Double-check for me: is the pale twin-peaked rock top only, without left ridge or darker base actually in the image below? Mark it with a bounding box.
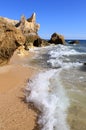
[16,13,40,36]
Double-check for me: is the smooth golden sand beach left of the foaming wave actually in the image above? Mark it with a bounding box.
[0,51,37,130]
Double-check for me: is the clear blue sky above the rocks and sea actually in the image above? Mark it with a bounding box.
[0,0,86,39]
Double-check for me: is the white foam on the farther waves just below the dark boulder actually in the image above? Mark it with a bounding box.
[47,45,82,68]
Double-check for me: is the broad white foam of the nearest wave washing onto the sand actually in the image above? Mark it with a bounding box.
[26,69,69,130]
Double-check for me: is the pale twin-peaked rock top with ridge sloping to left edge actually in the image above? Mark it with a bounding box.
[0,13,40,36]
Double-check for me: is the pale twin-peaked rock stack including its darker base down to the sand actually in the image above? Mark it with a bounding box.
[15,13,40,50]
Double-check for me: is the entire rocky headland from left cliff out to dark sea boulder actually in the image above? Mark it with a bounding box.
[0,13,74,65]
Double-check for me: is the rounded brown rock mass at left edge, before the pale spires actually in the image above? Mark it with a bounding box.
[0,18,25,64]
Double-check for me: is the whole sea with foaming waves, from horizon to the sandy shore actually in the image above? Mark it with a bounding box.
[26,40,86,130]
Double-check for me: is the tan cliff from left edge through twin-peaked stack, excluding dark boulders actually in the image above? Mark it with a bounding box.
[0,13,40,64]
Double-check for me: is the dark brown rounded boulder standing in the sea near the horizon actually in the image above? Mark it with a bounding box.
[49,33,65,44]
